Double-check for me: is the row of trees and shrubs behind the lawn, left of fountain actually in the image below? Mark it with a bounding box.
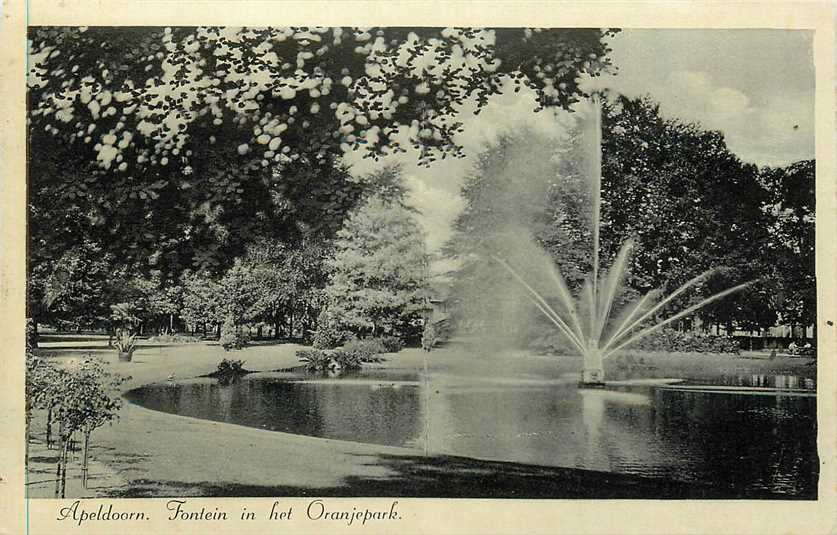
[28,167,428,346]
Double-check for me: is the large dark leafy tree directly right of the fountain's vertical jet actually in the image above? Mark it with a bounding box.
[602,97,775,329]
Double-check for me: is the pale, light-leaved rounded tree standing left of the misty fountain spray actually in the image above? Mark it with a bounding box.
[325,198,428,336]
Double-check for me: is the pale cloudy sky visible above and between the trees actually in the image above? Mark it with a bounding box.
[342,29,814,272]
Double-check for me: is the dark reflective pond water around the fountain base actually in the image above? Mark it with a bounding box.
[127,370,818,498]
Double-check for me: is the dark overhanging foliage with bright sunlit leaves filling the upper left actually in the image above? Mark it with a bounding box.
[28,27,614,276]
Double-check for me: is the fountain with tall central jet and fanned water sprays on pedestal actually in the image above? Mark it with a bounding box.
[494,94,753,387]
